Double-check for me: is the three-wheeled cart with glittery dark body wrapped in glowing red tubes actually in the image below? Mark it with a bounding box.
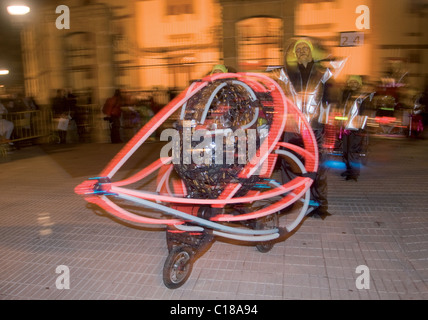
[75,73,318,288]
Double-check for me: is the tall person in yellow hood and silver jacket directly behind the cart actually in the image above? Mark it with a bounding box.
[280,38,333,219]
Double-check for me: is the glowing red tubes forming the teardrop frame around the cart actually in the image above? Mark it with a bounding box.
[75,73,318,225]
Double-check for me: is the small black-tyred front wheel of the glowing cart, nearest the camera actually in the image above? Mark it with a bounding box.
[163,246,193,289]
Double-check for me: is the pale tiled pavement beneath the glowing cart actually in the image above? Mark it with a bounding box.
[0,132,428,300]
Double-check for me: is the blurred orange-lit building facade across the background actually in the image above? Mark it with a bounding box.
[18,0,428,104]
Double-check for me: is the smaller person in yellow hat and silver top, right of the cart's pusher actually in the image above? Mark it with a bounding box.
[339,75,373,181]
